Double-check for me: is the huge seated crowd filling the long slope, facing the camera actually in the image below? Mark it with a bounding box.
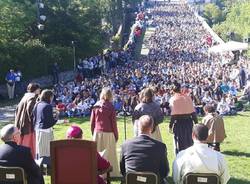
[50,4,250,120]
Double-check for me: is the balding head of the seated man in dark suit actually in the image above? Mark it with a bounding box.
[139,115,154,134]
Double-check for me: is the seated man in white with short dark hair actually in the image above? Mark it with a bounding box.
[173,124,230,184]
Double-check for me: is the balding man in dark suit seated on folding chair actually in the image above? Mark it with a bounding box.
[120,115,169,184]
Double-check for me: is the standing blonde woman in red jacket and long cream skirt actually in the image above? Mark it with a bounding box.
[90,87,120,176]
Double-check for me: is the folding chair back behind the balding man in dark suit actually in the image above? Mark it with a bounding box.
[126,172,158,184]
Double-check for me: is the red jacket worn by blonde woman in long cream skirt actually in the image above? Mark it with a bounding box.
[90,100,118,140]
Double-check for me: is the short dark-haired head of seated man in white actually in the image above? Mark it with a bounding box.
[193,123,208,142]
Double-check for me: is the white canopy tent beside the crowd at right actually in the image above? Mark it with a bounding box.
[209,41,248,53]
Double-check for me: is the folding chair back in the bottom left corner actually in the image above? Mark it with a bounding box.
[0,166,27,184]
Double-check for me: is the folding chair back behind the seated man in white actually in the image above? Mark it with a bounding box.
[183,173,220,184]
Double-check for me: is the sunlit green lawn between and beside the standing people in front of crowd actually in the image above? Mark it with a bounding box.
[42,112,250,184]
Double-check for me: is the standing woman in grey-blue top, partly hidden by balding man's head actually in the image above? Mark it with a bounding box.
[132,88,164,141]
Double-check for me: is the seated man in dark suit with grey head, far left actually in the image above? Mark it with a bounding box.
[0,124,44,184]
